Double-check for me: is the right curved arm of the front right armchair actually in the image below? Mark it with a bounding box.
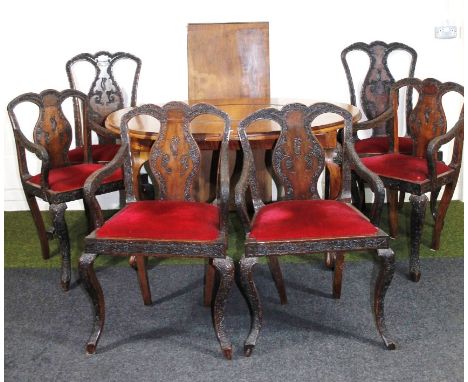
[345,141,385,226]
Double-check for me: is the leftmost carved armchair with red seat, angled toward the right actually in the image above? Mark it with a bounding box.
[7,89,123,291]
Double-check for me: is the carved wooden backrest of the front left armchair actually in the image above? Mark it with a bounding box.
[120,102,231,201]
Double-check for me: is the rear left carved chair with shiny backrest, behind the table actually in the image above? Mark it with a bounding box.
[65,51,141,163]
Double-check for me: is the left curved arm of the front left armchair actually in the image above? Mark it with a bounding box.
[83,144,128,229]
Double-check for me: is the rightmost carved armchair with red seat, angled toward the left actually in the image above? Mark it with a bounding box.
[355,78,464,281]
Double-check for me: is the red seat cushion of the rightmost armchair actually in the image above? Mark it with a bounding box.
[362,154,452,182]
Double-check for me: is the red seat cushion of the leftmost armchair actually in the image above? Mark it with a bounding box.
[29,163,123,192]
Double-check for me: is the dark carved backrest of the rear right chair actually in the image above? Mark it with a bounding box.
[341,41,417,136]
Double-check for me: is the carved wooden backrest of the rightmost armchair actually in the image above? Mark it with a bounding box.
[391,78,464,161]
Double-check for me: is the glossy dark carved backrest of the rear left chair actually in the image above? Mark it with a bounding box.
[65,51,141,146]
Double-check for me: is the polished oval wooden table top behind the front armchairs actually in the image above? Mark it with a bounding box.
[105,98,361,141]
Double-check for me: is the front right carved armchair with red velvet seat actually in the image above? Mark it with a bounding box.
[235,103,395,356]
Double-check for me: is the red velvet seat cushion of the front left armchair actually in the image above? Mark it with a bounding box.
[96,200,219,241]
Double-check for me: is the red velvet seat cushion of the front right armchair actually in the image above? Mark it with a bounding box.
[250,200,377,241]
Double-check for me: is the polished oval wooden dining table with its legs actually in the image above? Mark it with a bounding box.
[105,98,361,200]
